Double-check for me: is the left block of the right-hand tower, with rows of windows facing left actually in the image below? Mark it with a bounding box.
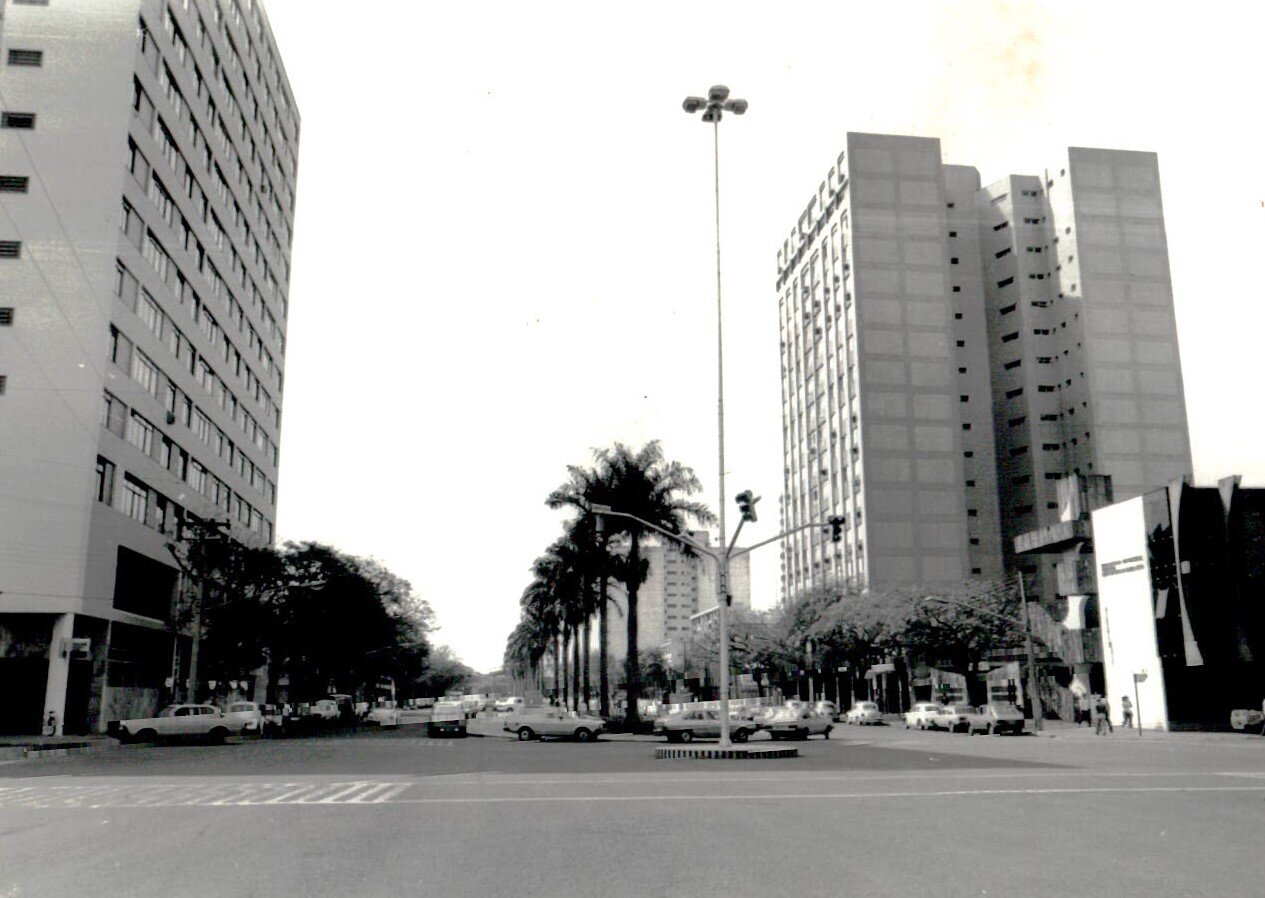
[777,134,1001,598]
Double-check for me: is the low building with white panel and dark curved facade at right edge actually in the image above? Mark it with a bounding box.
[1093,477,1265,730]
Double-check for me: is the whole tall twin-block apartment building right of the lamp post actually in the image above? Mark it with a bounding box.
[777,134,1190,609]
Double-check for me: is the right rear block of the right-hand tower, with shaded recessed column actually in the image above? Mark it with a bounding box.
[977,148,1192,569]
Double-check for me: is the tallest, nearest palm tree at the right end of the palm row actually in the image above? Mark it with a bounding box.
[593,440,715,730]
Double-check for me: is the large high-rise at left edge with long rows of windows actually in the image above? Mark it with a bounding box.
[0,0,299,732]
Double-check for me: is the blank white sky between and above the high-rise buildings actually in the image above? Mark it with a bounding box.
[266,0,1265,670]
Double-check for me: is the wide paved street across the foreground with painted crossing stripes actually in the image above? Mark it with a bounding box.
[0,727,1265,897]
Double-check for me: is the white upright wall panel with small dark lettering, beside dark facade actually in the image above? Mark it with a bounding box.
[1093,496,1169,730]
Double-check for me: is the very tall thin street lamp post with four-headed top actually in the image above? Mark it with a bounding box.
[681,85,746,747]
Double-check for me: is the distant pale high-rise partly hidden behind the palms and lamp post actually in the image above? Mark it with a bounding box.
[595,530,751,658]
